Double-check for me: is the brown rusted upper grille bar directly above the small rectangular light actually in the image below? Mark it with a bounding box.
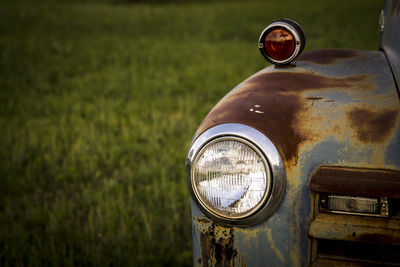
[310,166,400,198]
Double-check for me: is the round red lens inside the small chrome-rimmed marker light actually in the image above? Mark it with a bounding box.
[265,29,295,60]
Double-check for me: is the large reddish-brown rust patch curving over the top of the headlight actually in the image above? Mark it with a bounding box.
[197,71,368,164]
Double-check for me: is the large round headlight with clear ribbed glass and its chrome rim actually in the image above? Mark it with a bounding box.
[186,123,286,225]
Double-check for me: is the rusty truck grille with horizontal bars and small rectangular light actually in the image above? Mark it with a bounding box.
[308,166,400,266]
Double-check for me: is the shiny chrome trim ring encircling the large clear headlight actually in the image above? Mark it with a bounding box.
[186,123,286,226]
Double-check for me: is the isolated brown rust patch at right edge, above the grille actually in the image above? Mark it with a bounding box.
[347,108,398,143]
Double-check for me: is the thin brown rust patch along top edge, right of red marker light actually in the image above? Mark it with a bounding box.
[298,49,358,65]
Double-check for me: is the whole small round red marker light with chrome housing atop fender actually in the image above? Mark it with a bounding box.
[258,19,305,65]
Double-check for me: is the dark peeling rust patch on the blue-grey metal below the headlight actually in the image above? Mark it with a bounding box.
[198,223,237,267]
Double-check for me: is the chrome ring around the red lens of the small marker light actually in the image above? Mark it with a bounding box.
[258,19,306,65]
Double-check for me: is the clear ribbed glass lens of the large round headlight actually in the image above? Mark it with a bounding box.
[192,137,271,218]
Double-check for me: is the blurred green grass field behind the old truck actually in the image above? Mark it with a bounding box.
[0,0,382,266]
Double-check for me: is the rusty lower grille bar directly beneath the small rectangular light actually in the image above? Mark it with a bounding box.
[309,213,400,245]
